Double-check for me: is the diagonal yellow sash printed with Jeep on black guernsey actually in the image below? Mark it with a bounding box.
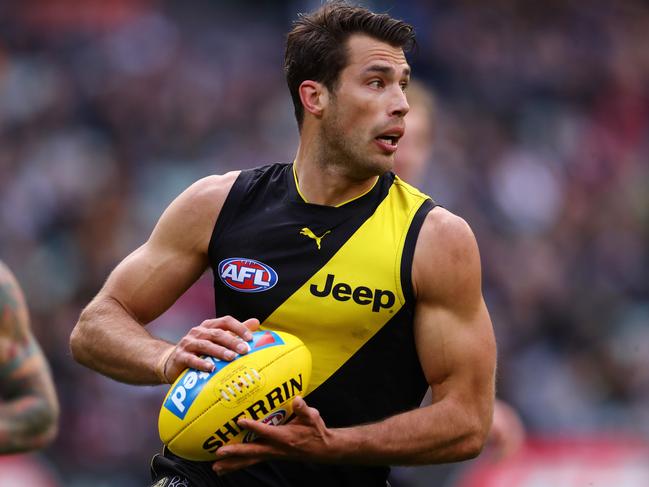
[262,178,428,392]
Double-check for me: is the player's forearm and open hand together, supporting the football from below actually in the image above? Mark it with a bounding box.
[212,395,493,474]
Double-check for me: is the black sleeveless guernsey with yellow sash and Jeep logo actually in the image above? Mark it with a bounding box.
[202,164,434,487]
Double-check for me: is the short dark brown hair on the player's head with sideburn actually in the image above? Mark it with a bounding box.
[284,0,415,128]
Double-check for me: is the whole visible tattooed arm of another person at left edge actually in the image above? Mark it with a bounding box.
[0,262,59,454]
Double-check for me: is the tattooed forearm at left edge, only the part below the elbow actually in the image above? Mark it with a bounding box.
[0,396,58,454]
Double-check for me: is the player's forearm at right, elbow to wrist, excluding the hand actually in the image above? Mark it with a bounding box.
[330,400,490,465]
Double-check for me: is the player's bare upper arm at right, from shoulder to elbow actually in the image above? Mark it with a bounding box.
[413,210,496,410]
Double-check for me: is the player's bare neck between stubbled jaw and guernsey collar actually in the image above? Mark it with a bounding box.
[295,142,378,206]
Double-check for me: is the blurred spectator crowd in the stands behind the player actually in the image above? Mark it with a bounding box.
[0,0,649,487]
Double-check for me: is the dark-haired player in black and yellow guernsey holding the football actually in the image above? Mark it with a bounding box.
[71,2,495,487]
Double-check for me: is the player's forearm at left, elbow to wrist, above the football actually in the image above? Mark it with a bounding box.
[70,297,172,384]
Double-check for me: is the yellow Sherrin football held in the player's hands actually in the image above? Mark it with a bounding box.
[158,330,311,460]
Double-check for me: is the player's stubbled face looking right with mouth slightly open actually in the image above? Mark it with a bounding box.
[322,35,410,178]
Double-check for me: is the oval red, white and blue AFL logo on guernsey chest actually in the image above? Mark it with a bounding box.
[219,257,277,293]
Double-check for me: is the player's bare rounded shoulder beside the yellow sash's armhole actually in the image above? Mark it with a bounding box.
[413,206,481,301]
